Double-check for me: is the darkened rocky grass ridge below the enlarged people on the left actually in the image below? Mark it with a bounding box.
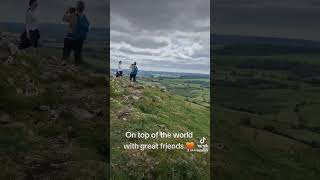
[0,33,108,179]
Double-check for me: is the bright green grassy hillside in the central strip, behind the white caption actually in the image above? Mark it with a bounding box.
[111,80,210,179]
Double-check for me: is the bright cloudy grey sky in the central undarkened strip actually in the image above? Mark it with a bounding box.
[110,0,210,74]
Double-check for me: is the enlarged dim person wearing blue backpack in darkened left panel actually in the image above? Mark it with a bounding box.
[62,1,90,66]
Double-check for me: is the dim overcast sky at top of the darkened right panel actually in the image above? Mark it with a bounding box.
[211,0,320,40]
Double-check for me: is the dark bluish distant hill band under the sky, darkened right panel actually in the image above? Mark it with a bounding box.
[211,34,320,56]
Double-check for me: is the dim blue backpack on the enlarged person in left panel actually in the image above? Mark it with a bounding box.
[73,16,90,40]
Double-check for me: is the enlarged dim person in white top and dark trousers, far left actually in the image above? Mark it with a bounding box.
[19,0,40,49]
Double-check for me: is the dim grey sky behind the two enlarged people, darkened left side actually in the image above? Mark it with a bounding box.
[0,0,109,27]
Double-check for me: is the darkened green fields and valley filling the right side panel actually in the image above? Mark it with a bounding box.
[213,45,320,180]
